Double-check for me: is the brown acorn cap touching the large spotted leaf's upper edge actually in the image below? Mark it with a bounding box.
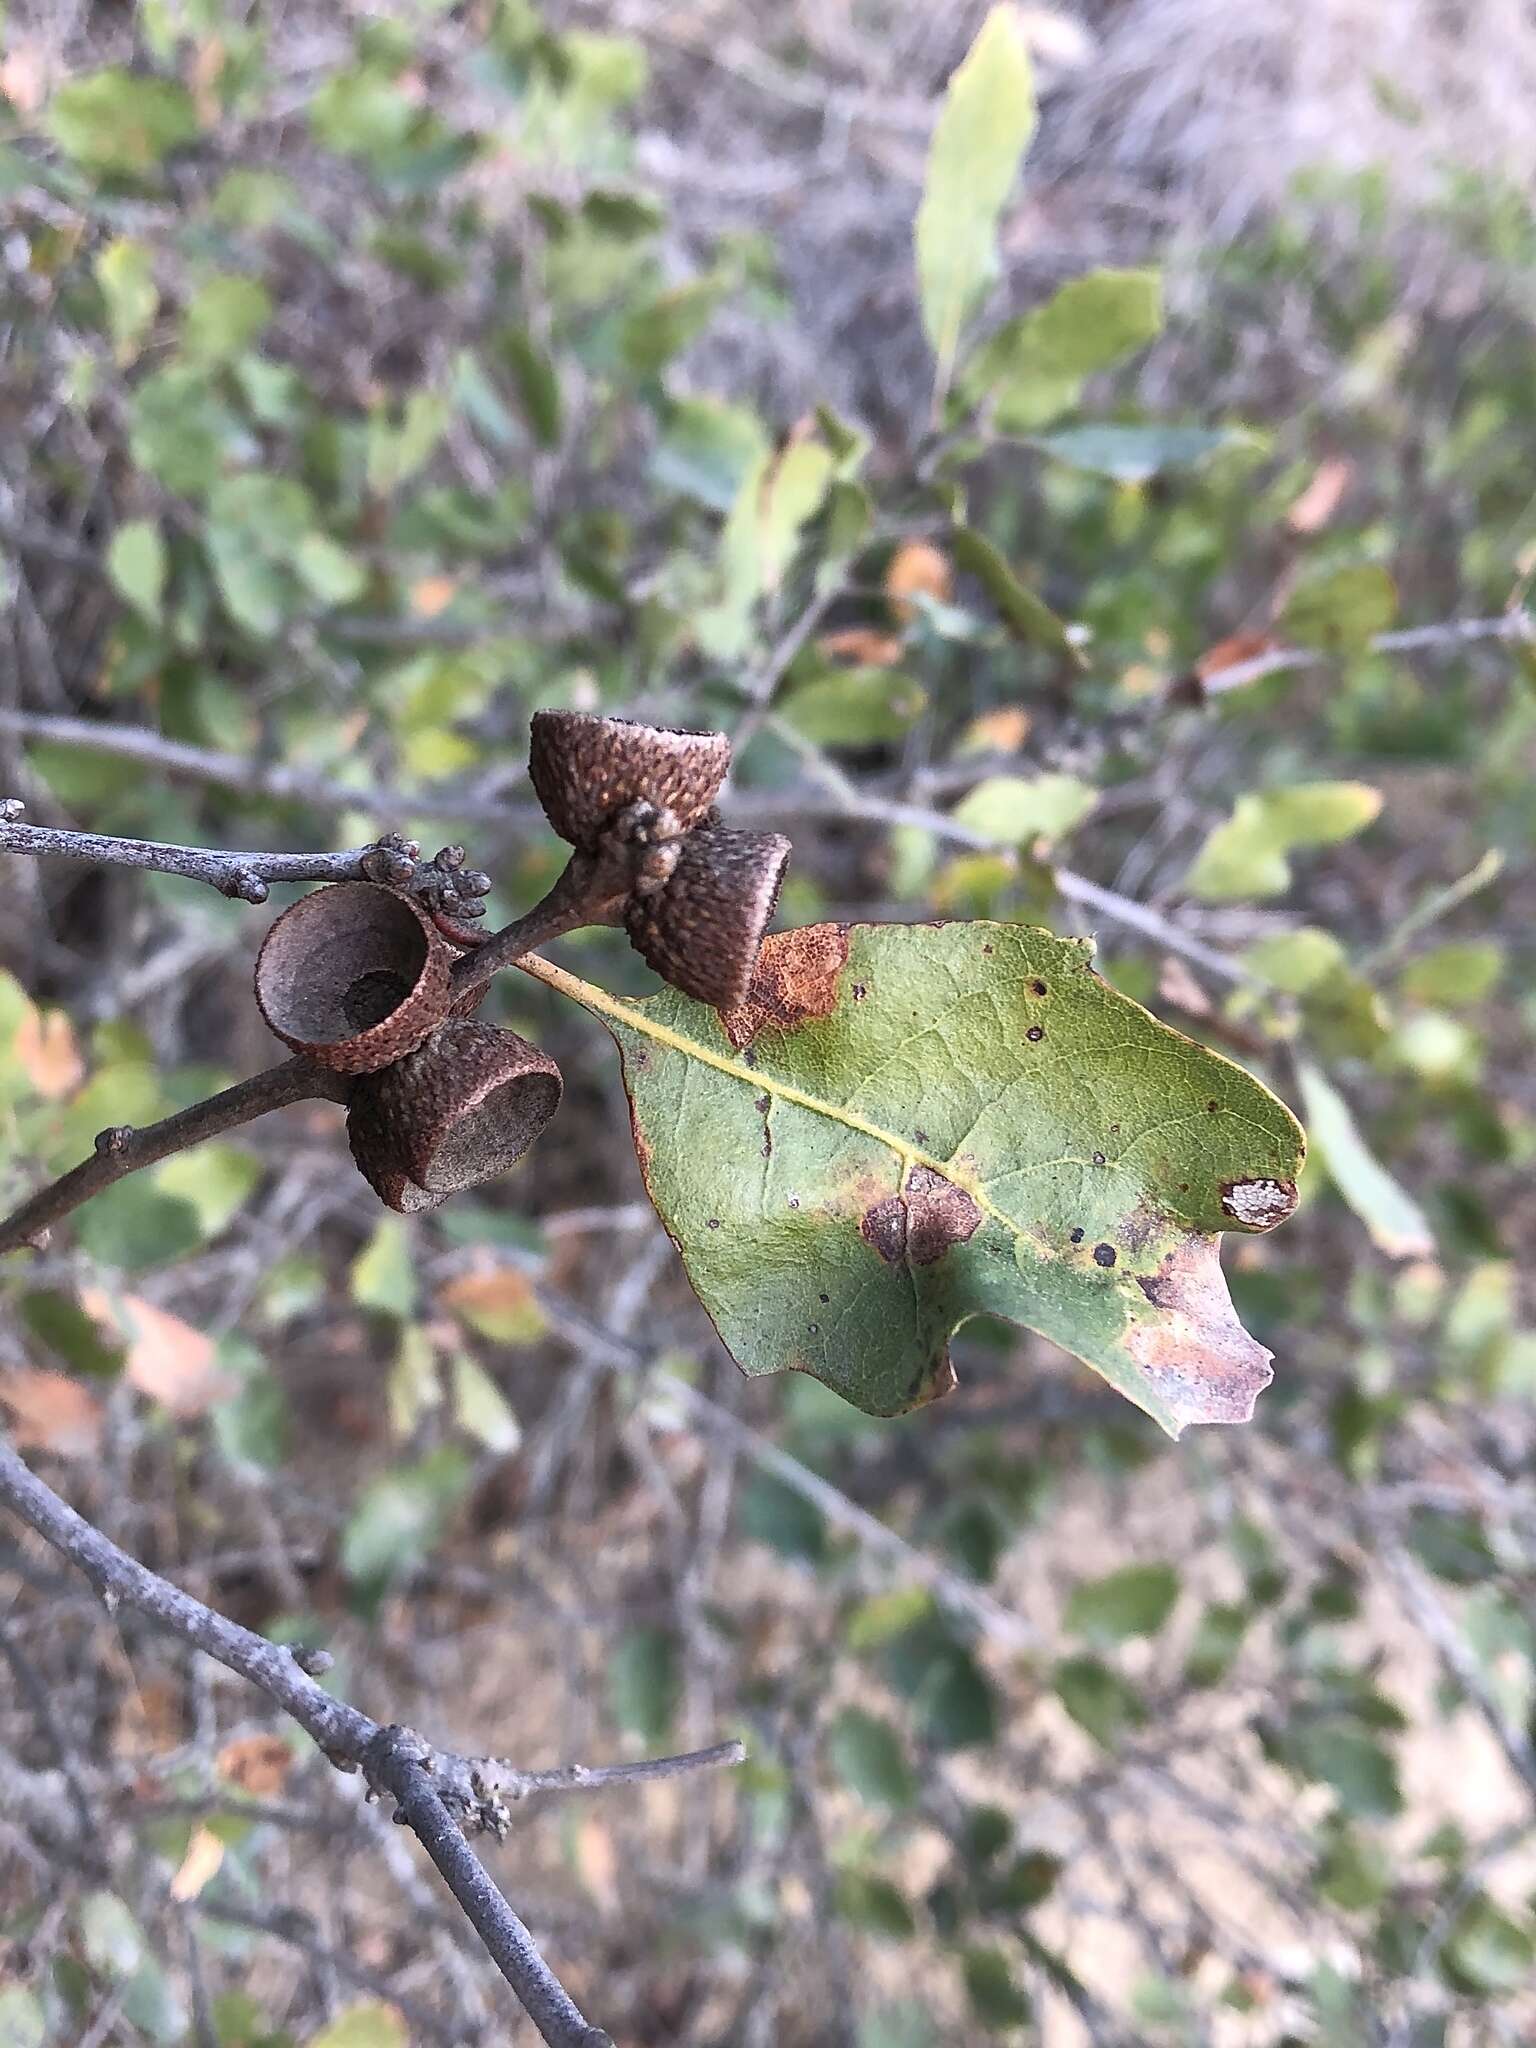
[625,825,791,1010]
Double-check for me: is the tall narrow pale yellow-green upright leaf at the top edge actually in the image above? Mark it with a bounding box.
[915,4,1034,393]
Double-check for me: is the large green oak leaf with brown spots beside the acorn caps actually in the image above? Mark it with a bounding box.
[522,922,1305,1436]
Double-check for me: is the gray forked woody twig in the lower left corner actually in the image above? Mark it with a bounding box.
[0,1440,743,2048]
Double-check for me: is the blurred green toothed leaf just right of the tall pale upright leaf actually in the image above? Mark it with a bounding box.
[965,270,1163,434]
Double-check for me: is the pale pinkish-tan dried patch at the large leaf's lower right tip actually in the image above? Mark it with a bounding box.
[1126,1235,1274,1430]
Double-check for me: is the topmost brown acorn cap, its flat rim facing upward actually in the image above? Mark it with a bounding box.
[528,711,731,848]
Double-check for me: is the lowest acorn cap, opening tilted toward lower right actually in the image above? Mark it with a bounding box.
[346,1018,563,1212]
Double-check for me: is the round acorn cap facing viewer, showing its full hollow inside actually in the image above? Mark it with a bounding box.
[256,883,453,1073]
